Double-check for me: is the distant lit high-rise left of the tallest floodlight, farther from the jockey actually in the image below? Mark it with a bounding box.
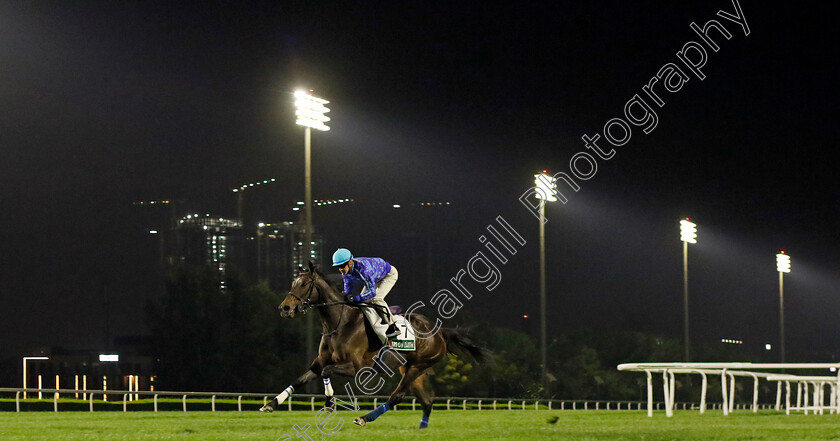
[166,215,245,289]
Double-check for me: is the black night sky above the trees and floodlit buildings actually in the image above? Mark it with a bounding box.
[0,0,840,361]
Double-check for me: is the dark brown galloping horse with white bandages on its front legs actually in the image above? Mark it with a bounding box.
[260,262,483,429]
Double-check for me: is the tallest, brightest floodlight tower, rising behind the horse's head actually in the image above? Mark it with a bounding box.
[295,90,330,374]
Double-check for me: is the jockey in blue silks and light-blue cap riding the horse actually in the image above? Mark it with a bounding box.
[333,248,400,344]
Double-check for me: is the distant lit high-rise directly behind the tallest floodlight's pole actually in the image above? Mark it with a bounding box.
[253,222,326,291]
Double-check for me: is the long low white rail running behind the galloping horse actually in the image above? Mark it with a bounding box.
[0,388,660,412]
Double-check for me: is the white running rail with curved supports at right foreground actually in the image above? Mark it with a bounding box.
[618,363,840,417]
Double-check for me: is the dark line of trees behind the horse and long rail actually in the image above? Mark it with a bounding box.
[146,265,774,400]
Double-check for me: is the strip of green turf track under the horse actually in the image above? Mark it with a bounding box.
[0,410,840,441]
